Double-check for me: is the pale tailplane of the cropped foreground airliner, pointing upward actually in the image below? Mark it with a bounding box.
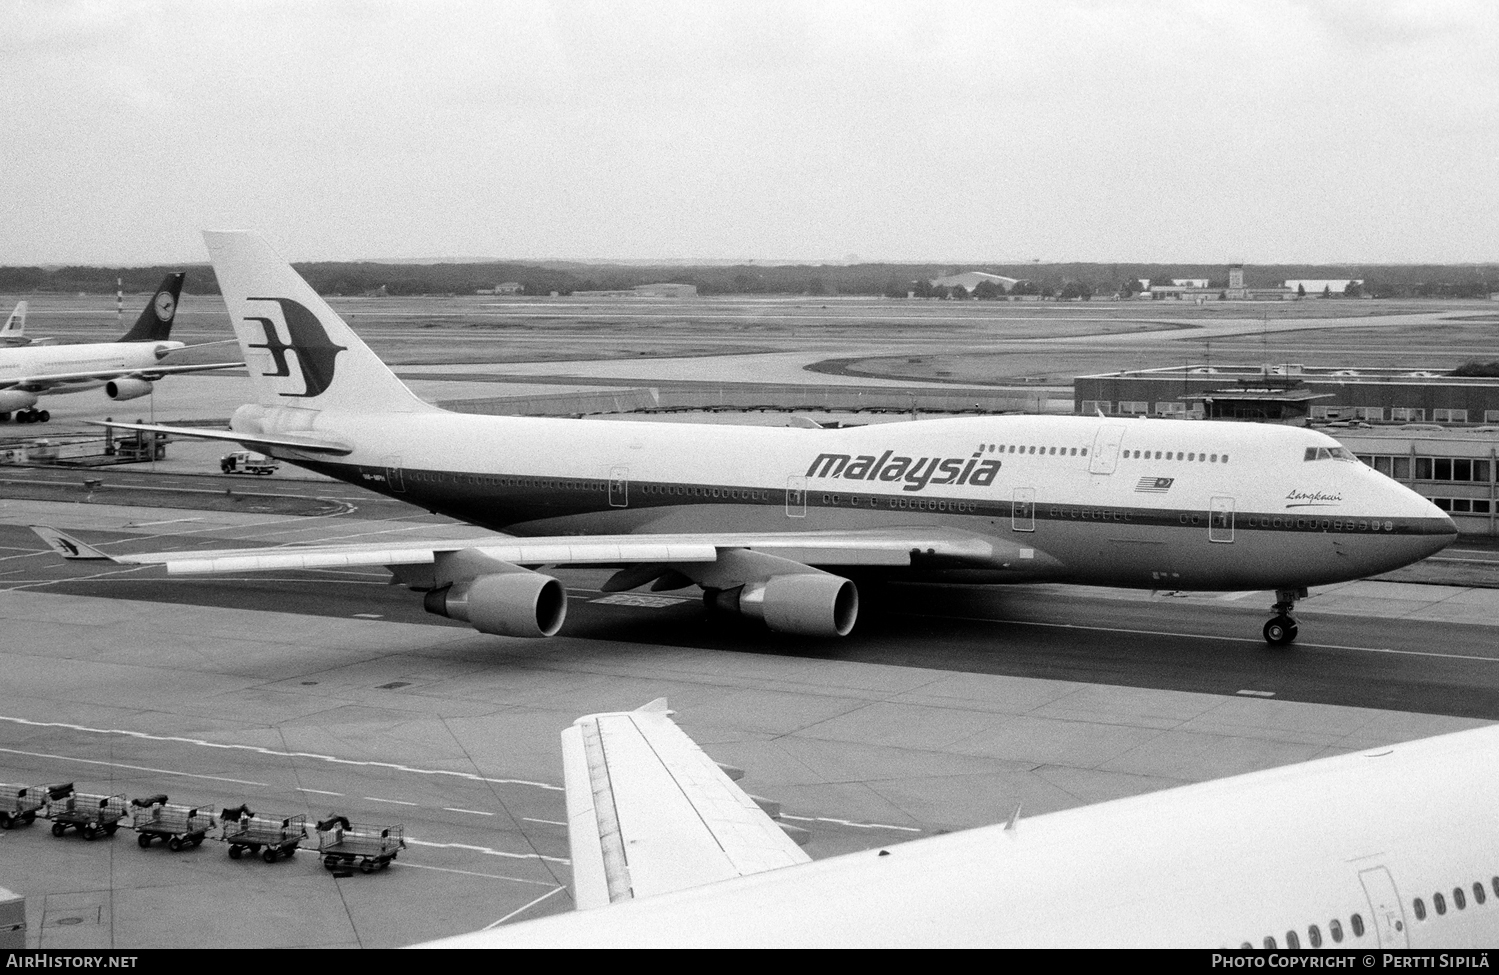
[562,699,811,909]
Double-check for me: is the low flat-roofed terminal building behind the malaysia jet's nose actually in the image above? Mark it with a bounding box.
[1073,365,1499,536]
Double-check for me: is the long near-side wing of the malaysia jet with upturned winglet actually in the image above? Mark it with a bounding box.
[33,525,1007,582]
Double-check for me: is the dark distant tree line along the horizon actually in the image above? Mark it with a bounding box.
[0,261,1499,300]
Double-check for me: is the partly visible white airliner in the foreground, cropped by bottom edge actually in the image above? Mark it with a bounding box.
[410,702,1499,951]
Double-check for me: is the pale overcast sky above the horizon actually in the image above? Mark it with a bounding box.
[0,0,1499,264]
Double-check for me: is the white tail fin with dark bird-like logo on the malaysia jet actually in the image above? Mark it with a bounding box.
[202,231,438,413]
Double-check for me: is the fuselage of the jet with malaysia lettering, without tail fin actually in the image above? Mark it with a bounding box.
[248,407,1456,590]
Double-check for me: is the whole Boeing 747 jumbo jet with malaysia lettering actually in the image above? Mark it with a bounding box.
[42,233,1457,644]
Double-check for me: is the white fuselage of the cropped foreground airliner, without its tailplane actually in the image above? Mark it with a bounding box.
[438,728,1499,950]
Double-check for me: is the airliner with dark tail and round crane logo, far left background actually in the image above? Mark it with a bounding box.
[0,272,243,423]
